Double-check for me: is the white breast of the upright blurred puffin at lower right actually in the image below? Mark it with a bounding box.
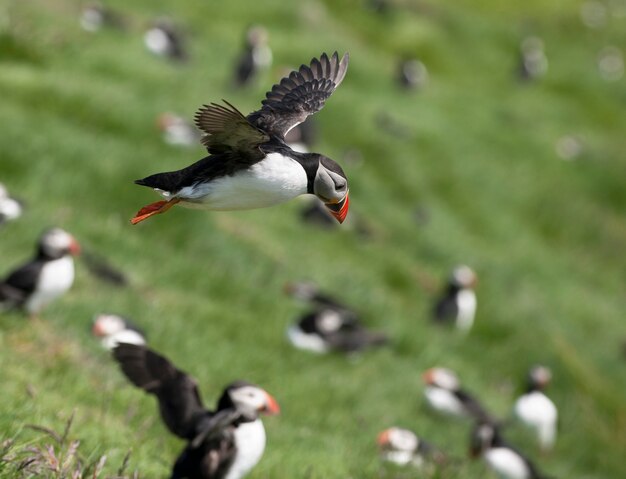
[514,391,558,449]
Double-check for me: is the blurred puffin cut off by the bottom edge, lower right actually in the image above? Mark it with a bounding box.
[470,422,544,479]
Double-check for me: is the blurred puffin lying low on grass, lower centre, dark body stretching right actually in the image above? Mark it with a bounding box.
[287,308,387,353]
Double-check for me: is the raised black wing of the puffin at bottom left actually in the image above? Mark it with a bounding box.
[113,344,210,440]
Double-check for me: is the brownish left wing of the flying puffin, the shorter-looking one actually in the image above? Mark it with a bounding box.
[195,100,269,161]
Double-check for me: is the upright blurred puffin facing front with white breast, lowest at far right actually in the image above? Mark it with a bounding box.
[513,366,558,452]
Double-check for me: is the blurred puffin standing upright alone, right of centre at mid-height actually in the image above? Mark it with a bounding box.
[433,265,478,332]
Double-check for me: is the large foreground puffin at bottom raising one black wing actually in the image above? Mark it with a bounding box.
[113,344,280,479]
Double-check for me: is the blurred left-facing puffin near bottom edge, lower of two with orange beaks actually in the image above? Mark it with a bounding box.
[377,427,446,468]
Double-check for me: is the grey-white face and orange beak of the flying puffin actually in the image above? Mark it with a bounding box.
[313,155,350,223]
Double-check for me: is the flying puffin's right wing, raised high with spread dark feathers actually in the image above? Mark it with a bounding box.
[248,52,350,138]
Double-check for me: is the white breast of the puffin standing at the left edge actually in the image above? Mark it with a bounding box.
[24,256,74,314]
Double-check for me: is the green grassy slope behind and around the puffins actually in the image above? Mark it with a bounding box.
[0,0,626,478]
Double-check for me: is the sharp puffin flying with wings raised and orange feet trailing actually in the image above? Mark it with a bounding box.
[131,52,349,224]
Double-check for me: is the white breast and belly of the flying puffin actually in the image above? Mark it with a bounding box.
[175,153,307,210]
